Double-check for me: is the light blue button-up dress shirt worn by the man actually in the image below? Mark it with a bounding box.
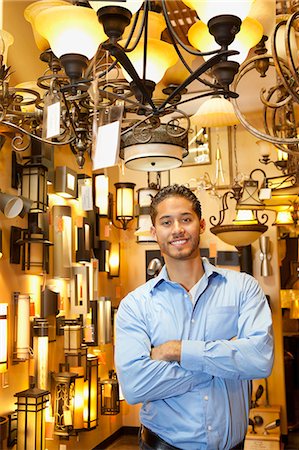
[115,258,273,450]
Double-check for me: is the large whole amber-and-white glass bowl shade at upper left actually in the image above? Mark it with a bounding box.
[35,6,107,59]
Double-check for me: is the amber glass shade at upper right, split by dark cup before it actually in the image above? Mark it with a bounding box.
[188,17,263,64]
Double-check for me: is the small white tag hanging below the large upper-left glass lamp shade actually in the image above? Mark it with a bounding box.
[43,91,61,139]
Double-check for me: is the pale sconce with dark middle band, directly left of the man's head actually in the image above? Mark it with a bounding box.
[134,185,159,243]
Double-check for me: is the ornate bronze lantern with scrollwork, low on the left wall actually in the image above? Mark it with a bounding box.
[52,372,77,436]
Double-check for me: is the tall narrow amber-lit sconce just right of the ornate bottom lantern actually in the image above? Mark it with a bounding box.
[84,355,98,430]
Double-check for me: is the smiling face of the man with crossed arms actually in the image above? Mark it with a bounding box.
[152,196,205,260]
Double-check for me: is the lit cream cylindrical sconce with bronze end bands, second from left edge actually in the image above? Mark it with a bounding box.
[13,292,30,363]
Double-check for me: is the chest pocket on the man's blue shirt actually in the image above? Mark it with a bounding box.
[205,306,238,341]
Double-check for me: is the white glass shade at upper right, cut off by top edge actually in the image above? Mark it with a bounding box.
[183,0,253,23]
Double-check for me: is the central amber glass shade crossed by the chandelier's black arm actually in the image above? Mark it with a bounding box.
[119,38,178,83]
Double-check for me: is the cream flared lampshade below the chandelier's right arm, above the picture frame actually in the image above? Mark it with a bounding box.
[192,97,239,127]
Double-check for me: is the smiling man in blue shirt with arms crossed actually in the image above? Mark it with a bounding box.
[116,185,273,450]
